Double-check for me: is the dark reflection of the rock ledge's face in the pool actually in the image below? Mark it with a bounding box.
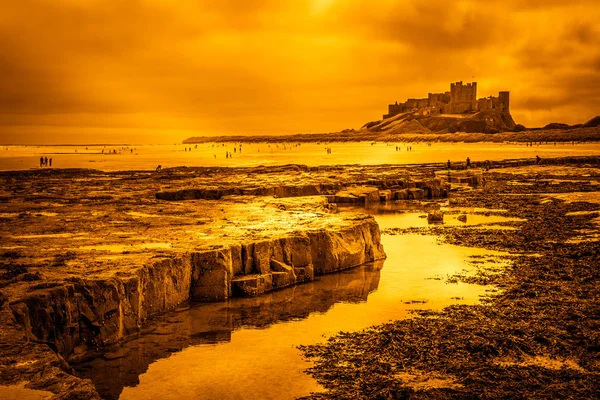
[76,261,383,399]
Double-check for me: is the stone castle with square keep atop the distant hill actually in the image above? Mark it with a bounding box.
[383,81,510,119]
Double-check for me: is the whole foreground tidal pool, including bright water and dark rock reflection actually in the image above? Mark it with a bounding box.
[76,214,506,399]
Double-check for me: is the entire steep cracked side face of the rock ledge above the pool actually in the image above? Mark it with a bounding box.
[5,217,385,359]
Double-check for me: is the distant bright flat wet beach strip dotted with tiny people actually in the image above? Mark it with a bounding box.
[0,142,600,171]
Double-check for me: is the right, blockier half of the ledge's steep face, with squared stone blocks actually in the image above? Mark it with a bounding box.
[191,219,385,301]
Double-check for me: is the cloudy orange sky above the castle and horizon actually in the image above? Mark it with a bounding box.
[0,0,600,144]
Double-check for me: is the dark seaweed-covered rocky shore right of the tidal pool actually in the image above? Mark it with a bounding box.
[303,164,600,399]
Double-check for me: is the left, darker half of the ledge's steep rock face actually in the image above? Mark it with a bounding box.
[10,257,192,359]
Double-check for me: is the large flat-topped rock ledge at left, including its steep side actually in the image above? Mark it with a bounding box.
[0,165,392,399]
